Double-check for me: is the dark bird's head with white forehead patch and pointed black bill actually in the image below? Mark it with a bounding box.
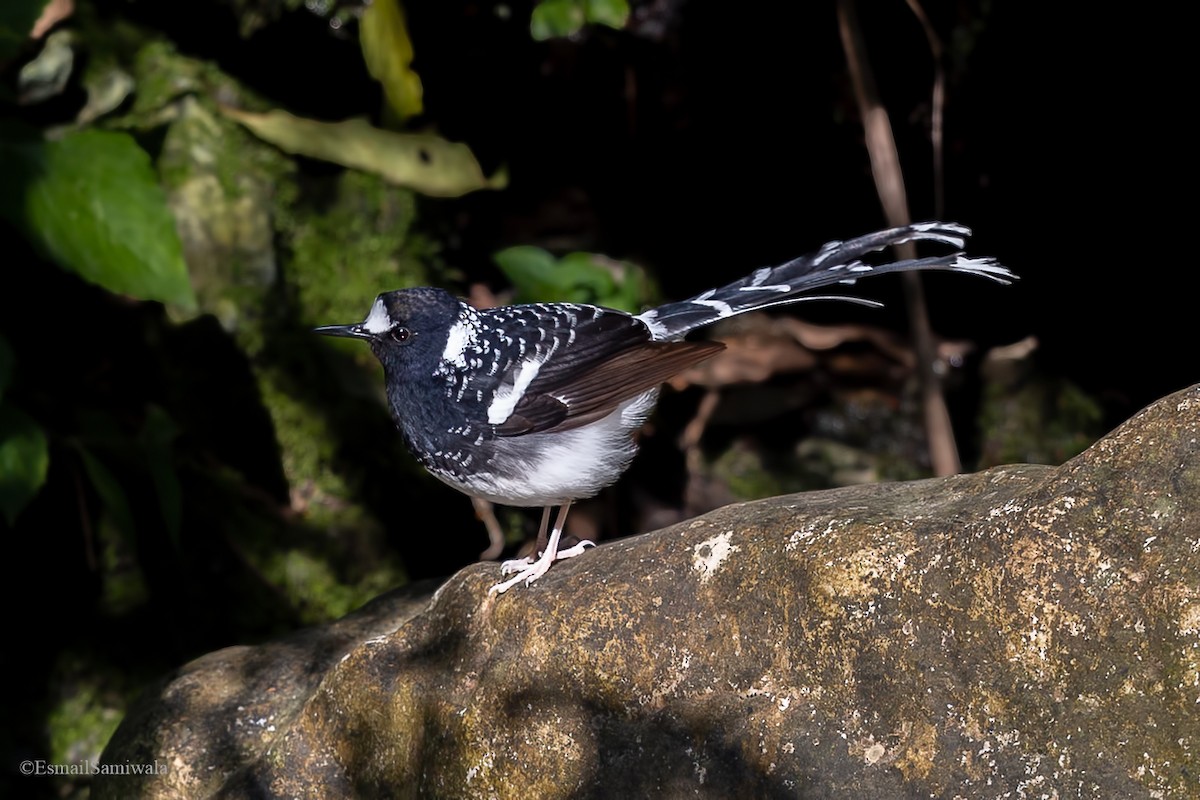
[314,288,462,373]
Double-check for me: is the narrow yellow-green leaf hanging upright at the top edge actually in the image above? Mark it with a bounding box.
[359,0,424,121]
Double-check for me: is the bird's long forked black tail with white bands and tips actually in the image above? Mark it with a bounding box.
[641,222,1016,339]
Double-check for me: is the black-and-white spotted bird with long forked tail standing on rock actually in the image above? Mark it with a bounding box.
[314,222,1016,594]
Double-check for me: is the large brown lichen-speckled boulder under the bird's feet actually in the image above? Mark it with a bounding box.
[95,385,1200,800]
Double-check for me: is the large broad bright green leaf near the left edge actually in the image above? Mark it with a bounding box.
[0,128,196,308]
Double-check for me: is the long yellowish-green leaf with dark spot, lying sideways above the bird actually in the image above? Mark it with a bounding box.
[221,108,508,197]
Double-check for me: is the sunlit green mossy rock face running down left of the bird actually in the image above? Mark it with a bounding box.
[77,34,436,622]
